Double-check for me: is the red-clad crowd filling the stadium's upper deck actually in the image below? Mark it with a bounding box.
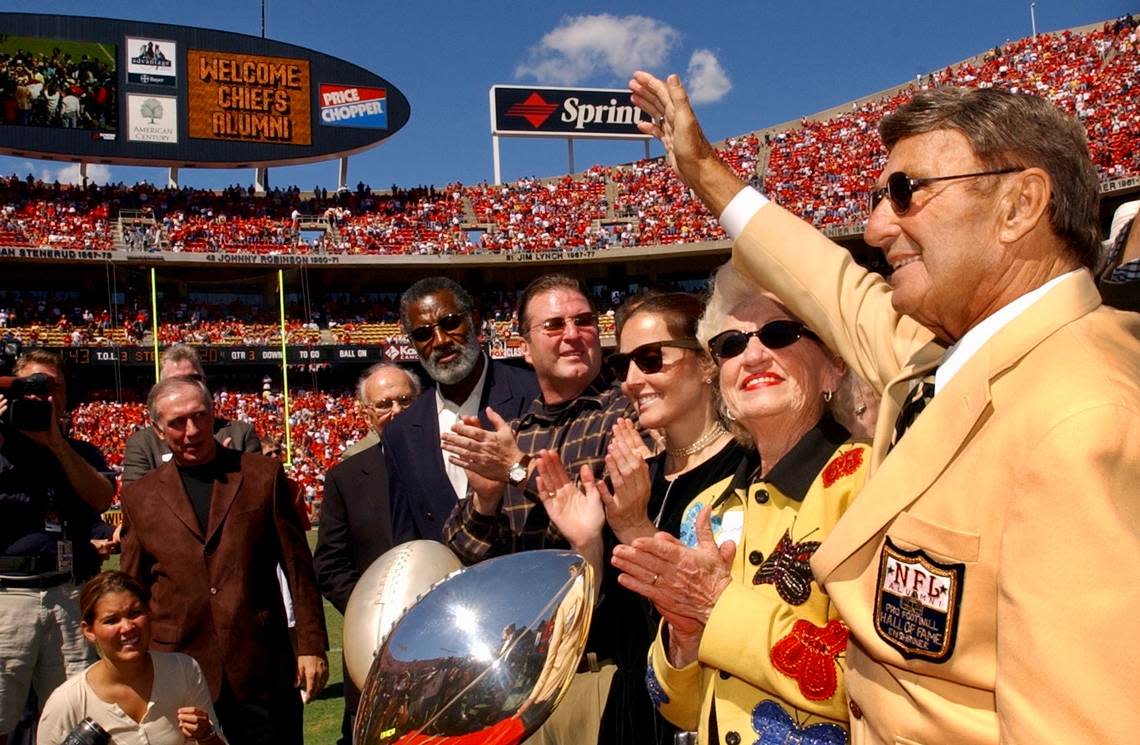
[0,19,1140,263]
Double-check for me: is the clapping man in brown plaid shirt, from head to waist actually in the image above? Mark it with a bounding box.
[442,275,636,564]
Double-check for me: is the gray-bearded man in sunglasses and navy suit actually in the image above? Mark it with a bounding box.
[384,277,538,543]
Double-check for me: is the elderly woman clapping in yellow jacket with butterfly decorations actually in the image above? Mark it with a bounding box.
[612,265,870,743]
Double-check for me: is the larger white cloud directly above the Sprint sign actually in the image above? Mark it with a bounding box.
[514,14,681,85]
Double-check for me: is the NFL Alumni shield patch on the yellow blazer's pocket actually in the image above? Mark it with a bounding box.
[874,538,966,662]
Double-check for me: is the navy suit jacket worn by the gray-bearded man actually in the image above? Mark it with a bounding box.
[384,360,538,543]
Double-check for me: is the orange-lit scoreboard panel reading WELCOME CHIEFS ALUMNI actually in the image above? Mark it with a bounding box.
[187,49,312,145]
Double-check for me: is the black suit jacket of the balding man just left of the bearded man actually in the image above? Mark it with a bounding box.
[314,444,392,613]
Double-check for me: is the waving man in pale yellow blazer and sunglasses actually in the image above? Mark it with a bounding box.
[630,73,1140,745]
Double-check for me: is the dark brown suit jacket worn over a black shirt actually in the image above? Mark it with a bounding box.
[122,448,328,701]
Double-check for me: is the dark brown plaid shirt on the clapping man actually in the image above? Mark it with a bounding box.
[443,378,637,564]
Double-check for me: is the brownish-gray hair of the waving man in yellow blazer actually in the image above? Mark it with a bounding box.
[879,88,1100,268]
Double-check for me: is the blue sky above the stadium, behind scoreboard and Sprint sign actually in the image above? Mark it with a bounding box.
[0,0,1140,189]
